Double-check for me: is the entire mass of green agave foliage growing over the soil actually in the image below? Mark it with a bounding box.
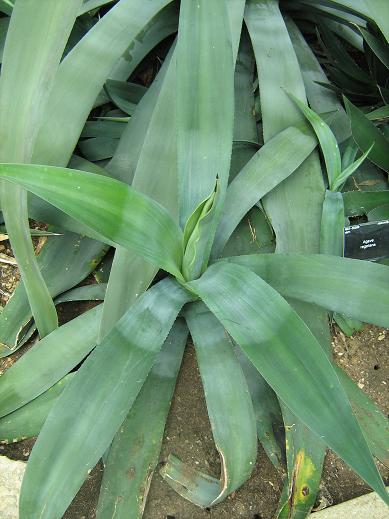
[0,0,389,519]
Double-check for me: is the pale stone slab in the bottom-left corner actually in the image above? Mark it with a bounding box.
[0,456,26,519]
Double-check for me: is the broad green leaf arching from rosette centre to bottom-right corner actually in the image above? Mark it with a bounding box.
[188,262,389,504]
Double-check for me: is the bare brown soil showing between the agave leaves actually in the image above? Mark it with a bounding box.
[0,249,389,519]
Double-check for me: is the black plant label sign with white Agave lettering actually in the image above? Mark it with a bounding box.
[344,220,389,260]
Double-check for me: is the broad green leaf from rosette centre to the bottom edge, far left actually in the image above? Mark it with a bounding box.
[20,279,188,519]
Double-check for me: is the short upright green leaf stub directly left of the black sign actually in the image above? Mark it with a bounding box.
[320,190,344,256]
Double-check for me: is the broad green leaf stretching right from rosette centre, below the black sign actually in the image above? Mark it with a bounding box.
[223,254,389,328]
